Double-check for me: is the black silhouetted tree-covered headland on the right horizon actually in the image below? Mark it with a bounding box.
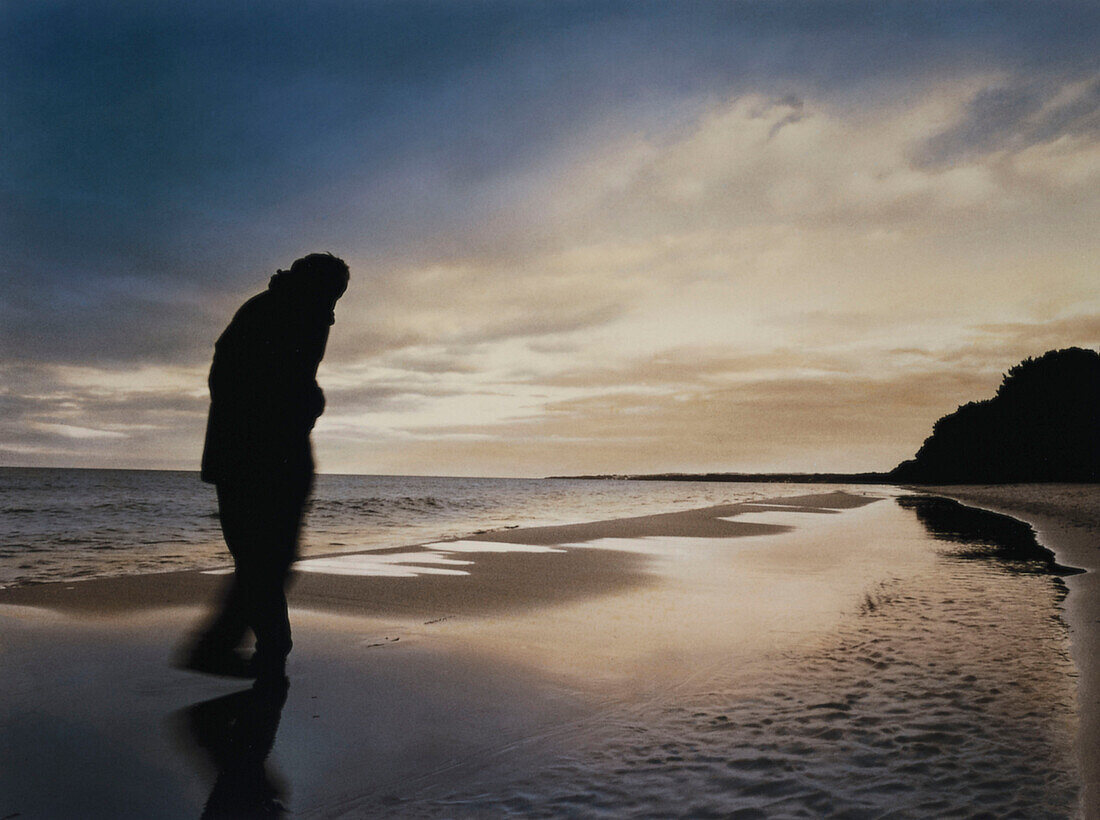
[890,348,1100,484]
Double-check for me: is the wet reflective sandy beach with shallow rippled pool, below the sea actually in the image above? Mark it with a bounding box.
[0,486,1097,818]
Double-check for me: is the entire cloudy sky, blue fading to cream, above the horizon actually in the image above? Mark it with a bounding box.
[0,0,1100,475]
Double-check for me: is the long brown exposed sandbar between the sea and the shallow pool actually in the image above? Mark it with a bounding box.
[0,491,868,617]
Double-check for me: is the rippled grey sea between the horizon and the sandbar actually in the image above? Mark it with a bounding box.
[0,467,809,587]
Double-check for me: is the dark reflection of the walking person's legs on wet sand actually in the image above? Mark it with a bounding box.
[178,678,289,820]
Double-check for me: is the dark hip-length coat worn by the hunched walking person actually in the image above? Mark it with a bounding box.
[202,277,332,483]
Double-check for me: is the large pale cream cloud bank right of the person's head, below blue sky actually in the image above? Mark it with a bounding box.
[319,79,1088,373]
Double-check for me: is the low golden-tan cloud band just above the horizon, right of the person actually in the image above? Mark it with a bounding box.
[320,316,1100,474]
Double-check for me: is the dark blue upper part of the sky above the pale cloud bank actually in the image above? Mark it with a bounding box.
[0,0,1100,361]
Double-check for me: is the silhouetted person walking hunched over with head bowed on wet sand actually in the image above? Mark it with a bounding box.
[183,253,348,677]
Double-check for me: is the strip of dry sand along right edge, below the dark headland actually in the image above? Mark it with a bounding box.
[919,484,1100,820]
